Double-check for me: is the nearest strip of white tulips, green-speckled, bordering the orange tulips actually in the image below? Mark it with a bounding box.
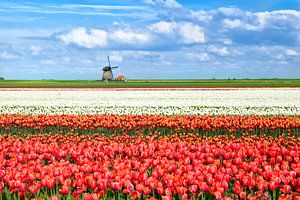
[0,105,300,116]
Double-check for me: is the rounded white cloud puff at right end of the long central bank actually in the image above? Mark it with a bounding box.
[179,23,205,44]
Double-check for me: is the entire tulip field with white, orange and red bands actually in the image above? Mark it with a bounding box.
[0,88,300,200]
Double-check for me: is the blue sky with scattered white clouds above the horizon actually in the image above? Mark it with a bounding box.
[0,0,300,80]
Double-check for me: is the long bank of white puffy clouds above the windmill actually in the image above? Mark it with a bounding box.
[59,21,206,49]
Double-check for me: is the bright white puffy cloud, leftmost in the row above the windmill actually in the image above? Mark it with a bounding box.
[59,27,107,48]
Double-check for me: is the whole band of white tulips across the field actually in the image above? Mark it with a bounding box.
[0,88,300,115]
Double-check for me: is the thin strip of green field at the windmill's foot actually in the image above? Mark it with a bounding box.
[0,79,300,88]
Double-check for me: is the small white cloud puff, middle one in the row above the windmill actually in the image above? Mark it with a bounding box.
[112,29,150,44]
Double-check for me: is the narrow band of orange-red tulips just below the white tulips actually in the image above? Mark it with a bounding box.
[0,114,300,135]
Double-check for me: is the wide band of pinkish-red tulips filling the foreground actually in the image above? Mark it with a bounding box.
[0,134,300,200]
